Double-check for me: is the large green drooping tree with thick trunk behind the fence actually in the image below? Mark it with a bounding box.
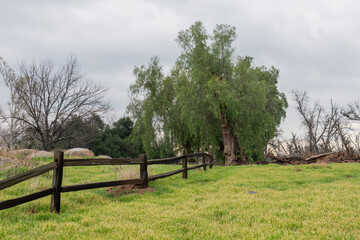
[128,22,287,165]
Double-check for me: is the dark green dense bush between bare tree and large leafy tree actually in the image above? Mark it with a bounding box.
[91,117,142,158]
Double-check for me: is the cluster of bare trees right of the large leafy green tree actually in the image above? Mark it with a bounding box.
[268,91,360,157]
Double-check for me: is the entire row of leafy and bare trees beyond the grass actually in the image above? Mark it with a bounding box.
[0,22,360,165]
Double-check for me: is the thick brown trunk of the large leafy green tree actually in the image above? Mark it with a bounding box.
[219,114,239,166]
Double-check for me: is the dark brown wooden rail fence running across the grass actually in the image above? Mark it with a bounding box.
[0,152,213,213]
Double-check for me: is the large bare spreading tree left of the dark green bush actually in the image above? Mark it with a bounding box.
[0,57,109,150]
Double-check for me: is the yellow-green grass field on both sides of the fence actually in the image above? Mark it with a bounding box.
[0,158,360,239]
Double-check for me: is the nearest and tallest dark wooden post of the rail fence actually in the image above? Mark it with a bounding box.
[51,151,64,213]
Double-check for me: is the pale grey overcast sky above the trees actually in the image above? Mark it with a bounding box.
[0,0,360,138]
